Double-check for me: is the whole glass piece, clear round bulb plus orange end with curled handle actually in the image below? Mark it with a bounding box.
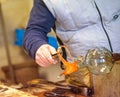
[57,46,113,75]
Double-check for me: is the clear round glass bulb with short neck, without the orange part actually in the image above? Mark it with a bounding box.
[79,47,113,74]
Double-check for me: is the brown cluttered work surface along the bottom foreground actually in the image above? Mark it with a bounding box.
[0,79,85,97]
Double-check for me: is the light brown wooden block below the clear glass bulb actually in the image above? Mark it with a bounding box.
[93,61,120,97]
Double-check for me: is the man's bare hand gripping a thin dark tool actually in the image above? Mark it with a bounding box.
[35,44,57,67]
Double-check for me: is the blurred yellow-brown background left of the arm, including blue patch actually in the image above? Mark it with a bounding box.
[0,0,64,83]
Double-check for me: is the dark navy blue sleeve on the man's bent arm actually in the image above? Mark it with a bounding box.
[23,0,55,59]
